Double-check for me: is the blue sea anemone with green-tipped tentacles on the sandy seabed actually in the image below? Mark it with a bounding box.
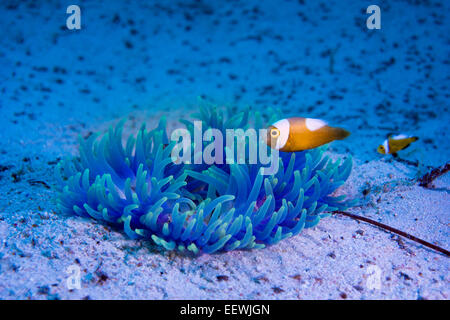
[56,107,352,254]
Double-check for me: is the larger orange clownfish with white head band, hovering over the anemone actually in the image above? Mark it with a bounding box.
[266,117,350,152]
